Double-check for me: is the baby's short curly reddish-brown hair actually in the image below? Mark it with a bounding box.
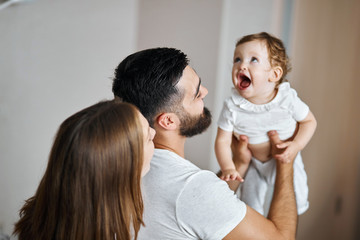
[235,32,291,86]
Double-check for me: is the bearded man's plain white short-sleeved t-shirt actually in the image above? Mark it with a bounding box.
[138,149,246,240]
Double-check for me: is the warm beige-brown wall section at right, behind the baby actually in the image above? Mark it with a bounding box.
[292,0,360,240]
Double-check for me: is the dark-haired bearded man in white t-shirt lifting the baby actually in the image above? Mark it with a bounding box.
[113,48,297,240]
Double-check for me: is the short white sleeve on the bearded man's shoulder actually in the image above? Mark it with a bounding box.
[176,171,246,240]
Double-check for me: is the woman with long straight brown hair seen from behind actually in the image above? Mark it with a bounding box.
[14,101,155,240]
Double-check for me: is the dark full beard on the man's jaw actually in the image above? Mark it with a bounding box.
[179,107,211,137]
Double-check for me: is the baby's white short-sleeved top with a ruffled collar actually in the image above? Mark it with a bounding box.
[218,82,309,144]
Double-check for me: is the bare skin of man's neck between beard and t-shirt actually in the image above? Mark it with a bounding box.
[154,134,186,158]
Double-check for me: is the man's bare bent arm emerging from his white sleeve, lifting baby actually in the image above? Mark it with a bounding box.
[224,131,297,240]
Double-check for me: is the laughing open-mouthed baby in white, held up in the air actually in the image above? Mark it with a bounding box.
[215,32,316,216]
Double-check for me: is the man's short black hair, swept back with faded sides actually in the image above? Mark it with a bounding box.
[112,48,189,126]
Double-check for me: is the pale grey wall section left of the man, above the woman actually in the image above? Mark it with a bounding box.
[0,0,137,234]
